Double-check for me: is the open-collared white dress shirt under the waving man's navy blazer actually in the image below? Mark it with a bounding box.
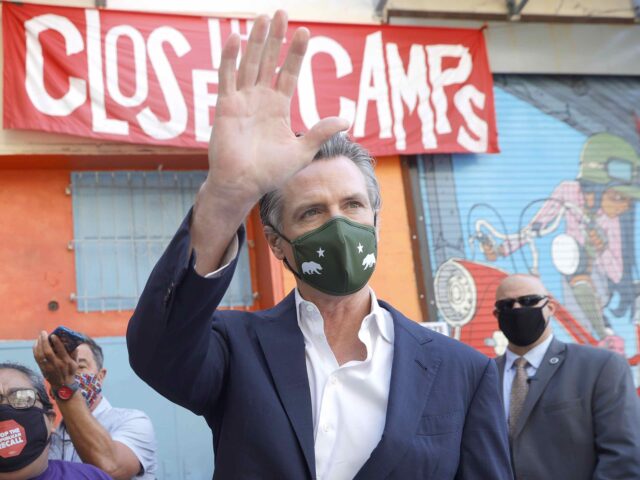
[295,289,394,480]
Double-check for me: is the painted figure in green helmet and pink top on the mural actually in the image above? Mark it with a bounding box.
[476,133,640,353]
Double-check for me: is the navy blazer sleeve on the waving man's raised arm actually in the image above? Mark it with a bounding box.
[127,212,244,415]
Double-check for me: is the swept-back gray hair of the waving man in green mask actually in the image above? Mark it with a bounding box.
[258,133,382,231]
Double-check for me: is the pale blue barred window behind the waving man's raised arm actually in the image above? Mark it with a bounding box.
[71,171,253,312]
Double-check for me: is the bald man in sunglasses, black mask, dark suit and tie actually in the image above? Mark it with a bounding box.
[493,275,640,480]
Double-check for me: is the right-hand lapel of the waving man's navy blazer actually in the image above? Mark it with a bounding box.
[354,302,442,480]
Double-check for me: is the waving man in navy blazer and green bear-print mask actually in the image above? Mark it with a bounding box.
[127,11,512,480]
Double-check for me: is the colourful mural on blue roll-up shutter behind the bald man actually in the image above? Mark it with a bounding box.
[418,76,640,390]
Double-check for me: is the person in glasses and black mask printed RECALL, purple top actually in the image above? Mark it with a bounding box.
[0,362,111,480]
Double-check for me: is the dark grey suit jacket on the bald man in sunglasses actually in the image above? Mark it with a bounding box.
[496,339,640,480]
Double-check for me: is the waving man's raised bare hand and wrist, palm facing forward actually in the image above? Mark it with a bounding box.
[191,11,349,273]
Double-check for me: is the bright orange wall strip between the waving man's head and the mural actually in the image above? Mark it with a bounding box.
[284,157,423,321]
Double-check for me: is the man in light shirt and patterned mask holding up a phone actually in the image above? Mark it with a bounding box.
[34,332,157,480]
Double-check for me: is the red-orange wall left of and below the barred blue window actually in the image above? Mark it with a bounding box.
[0,170,131,340]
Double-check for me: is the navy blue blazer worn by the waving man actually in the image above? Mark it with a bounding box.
[127,217,512,480]
